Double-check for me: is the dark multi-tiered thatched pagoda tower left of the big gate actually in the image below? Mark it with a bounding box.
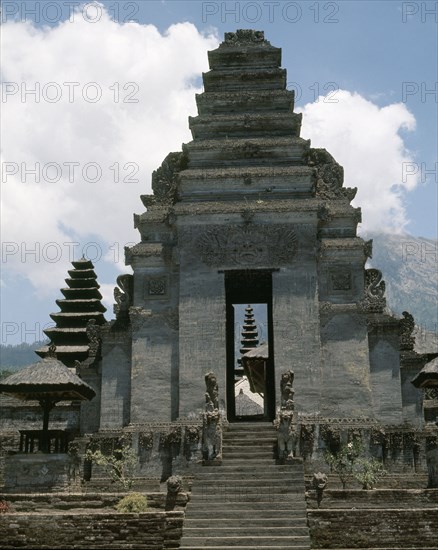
[36,258,106,367]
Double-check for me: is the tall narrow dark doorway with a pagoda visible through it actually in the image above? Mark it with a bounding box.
[225,269,275,422]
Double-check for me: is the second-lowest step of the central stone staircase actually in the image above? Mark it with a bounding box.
[184,522,309,538]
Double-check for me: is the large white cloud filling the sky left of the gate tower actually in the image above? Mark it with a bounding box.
[1,12,218,295]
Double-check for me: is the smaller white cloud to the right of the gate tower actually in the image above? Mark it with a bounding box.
[301,90,419,232]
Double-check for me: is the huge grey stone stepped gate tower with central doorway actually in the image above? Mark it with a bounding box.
[95,30,425,436]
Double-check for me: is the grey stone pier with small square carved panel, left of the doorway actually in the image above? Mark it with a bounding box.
[130,254,178,424]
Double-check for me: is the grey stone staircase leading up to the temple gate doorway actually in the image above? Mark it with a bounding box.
[180,422,310,550]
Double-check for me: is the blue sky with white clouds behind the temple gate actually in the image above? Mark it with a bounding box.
[1,0,438,344]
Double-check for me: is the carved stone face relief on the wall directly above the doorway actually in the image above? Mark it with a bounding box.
[196,224,297,266]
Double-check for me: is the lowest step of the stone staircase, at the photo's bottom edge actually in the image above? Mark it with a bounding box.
[180,535,310,550]
